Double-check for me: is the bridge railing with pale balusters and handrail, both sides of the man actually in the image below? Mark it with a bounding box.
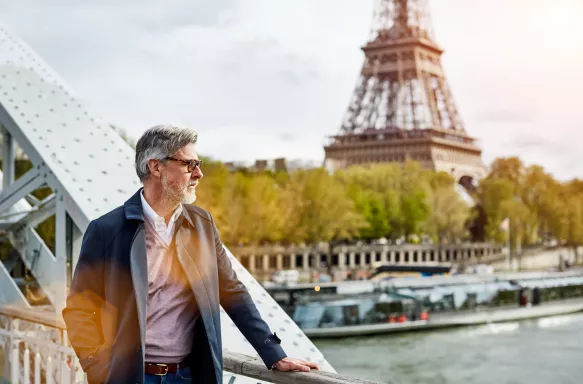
[0,306,374,384]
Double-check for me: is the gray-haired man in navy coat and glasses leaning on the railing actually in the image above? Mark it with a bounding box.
[63,126,318,384]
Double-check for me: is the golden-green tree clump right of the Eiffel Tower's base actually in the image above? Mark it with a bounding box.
[477,157,583,258]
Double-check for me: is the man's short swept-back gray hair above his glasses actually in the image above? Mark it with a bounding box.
[136,125,198,183]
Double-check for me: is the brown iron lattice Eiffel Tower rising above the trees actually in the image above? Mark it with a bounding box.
[324,0,486,188]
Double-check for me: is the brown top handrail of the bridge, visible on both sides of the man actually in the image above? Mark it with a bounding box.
[0,306,384,384]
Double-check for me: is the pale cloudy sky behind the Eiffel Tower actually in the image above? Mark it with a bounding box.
[0,0,583,180]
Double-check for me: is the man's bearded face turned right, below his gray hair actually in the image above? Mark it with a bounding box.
[160,144,203,205]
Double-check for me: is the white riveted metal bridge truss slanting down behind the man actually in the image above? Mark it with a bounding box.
[0,26,334,383]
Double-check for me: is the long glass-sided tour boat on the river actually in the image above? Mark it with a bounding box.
[271,271,583,338]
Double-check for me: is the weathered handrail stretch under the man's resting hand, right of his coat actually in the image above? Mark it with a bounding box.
[223,351,377,384]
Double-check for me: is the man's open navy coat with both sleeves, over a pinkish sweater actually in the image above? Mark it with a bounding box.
[63,189,286,384]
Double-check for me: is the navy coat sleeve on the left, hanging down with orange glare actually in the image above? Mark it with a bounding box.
[63,221,106,371]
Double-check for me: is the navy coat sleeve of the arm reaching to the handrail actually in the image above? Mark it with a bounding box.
[211,217,286,369]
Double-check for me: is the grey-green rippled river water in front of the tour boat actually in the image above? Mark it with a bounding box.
[315,313,583,384]
